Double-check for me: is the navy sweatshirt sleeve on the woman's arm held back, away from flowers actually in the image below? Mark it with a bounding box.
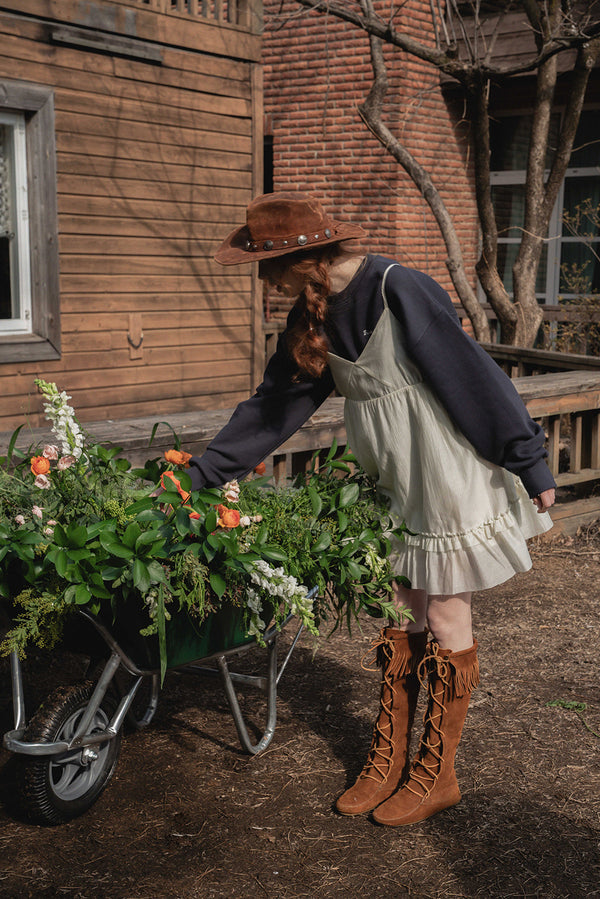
[386,266,555,497]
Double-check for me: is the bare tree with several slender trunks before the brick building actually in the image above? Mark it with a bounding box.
[280,0,600,346]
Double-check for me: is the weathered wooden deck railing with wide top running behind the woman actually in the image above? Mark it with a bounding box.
[0,371,600,533]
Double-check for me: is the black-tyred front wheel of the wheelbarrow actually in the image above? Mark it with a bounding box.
[17,681,121,824]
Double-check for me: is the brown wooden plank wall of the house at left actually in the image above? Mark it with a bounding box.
[0,0,262,430]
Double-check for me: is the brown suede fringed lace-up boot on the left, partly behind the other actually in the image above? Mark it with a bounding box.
[336,627,427,815]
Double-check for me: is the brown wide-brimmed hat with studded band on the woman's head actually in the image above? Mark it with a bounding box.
[215,191,366,265]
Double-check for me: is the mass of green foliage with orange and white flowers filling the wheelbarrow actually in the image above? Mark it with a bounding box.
[0,380,410,675]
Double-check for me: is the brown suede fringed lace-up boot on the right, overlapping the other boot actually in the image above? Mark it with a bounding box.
[373,641,479,826]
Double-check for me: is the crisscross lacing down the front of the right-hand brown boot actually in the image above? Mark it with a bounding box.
[404,642,451,799]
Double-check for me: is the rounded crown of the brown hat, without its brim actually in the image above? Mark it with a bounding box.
[246,192,331,241]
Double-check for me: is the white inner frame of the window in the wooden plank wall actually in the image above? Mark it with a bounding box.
[0,112,32,336]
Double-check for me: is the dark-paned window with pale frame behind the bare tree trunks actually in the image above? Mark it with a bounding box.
[491,110,600,304]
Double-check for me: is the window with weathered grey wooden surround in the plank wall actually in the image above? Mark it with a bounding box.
[0,80,60,363]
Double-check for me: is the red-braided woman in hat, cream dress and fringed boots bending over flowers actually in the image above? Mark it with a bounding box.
[185,192,555,825]
